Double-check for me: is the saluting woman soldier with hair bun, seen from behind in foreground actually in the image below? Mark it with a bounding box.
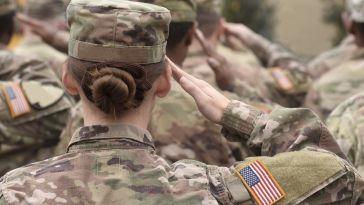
[0,0,364,205]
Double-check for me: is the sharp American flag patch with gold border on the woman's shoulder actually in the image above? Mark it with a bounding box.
[237,160,285,205]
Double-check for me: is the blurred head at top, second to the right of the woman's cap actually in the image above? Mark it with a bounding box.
[196,0,224,38]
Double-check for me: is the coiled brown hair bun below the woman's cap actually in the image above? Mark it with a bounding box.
[91,67,136,114]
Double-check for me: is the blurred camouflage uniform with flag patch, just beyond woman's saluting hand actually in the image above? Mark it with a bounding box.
[184,0,310,107]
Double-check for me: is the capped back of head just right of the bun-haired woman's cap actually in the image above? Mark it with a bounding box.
[129,0,197,49]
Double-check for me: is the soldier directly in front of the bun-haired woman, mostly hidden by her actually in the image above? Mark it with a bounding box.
[58,0,235,166]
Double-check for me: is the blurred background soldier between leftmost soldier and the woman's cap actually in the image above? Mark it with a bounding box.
[14,0,67,76]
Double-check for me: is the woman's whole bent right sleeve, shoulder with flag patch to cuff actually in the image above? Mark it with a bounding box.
[210,101,364,204]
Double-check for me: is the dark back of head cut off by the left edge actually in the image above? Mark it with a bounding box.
[0,0,16,44]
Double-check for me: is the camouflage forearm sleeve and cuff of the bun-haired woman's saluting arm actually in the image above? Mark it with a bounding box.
[222,101,346,159]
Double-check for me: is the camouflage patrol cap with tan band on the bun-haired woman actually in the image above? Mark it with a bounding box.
[67,0,171,64]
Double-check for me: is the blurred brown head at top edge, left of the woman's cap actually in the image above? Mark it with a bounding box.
[24,0,66,21]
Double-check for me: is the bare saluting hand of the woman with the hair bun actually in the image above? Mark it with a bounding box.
[167,58,230,123]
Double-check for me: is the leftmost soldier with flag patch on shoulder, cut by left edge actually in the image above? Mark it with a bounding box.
[0,0,71,176]
